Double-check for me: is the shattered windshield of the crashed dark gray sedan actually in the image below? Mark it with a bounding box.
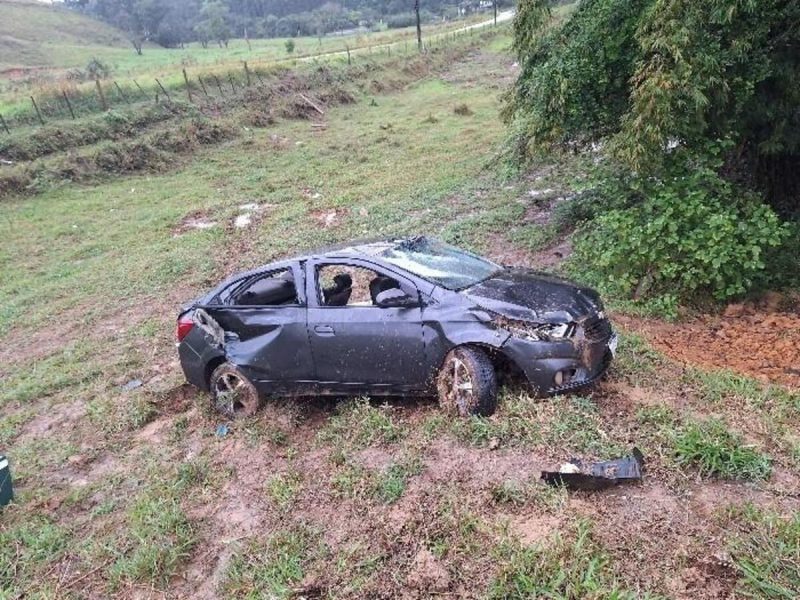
[380,237,502,290]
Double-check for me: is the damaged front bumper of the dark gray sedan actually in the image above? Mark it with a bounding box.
[503,329,616,395]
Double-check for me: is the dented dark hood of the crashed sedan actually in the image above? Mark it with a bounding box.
[463,268,603,323]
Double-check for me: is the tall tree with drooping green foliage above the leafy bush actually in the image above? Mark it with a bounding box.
[504,0,800,215]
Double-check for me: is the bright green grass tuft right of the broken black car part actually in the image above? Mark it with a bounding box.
[674,419,772,480]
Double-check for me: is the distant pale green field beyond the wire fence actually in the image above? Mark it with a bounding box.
[0,0,496,118]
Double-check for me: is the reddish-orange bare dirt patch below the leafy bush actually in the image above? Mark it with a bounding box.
[624,304,800,388]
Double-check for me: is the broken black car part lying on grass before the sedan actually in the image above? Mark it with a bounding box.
[542,448,644,491]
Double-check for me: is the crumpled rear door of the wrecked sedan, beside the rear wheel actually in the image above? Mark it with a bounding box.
[205,265,314,391]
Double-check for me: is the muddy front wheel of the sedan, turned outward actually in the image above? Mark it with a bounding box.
[436,346,497,417]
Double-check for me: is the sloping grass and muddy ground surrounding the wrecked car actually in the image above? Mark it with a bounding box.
[0,23,800,599]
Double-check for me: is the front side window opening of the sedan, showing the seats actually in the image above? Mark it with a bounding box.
[317,264,403,306]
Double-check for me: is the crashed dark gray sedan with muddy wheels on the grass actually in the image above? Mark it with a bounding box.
[177,237,617,417]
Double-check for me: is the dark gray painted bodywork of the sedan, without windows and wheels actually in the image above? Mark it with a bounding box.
[179,239,608,394]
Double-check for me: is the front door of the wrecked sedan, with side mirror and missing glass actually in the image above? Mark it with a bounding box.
[306,259,427,391]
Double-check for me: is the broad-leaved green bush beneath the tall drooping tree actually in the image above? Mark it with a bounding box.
[572,157,786,314]
